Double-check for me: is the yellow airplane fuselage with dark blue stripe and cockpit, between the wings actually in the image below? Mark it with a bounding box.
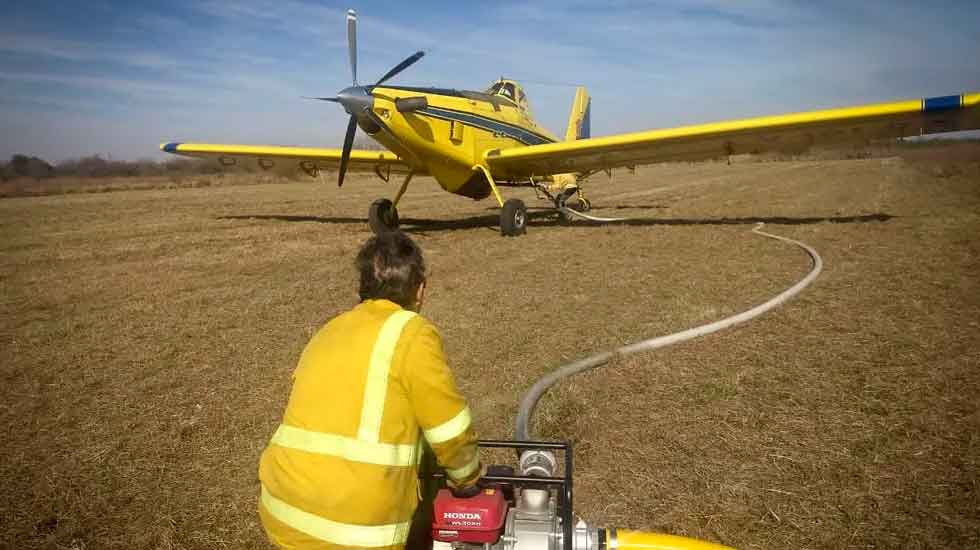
[358,81,559,199]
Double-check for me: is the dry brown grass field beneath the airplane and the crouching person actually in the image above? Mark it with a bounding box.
[0,148,980,550]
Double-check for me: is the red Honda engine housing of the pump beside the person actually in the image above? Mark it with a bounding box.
[432,487,507,543]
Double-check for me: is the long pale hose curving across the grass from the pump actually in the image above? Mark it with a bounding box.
[515,222,823,441]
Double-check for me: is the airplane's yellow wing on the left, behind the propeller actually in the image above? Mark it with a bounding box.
[160,143,409,175]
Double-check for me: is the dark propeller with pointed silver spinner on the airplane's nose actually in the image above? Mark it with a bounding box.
[306,10,425,187]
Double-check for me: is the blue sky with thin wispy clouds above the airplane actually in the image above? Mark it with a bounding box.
[0,0,980,161]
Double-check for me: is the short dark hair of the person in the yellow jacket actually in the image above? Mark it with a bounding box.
[355,231,425,308]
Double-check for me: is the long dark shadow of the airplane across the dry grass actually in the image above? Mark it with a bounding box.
[216,207,895,233]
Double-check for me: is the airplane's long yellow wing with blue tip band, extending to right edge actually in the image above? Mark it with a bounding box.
[485,93,980,179]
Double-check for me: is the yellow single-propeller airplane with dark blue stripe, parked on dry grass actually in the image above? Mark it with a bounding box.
[160,10,980,236]
